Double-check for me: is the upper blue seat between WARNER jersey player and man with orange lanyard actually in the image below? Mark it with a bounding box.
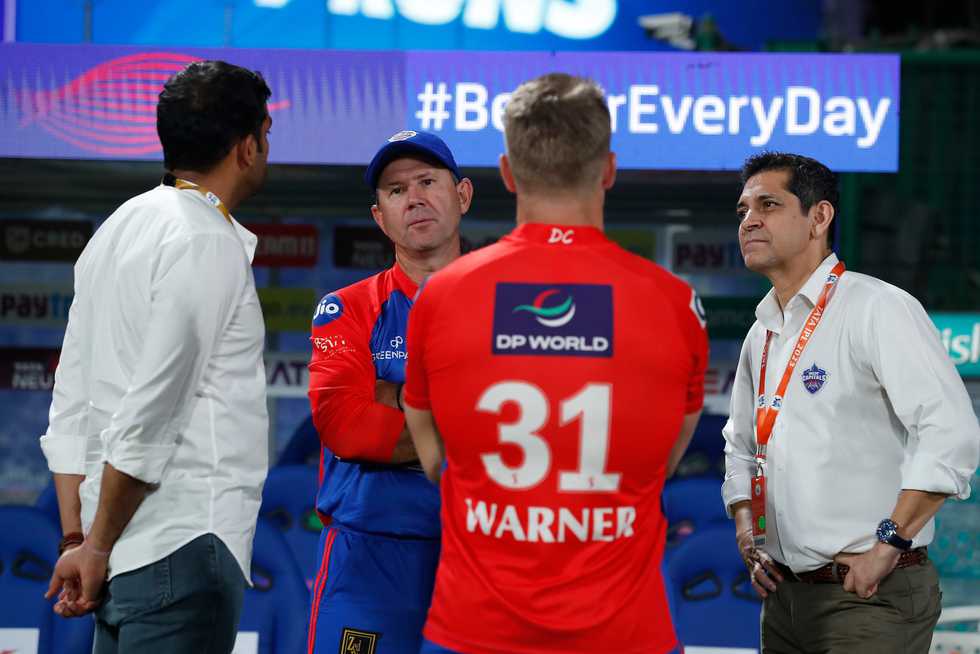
[663,477,728,561]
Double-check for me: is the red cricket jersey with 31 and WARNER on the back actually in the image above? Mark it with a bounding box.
[405,224,708,654]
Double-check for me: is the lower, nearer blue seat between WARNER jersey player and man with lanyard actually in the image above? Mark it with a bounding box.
[667,523,762,649]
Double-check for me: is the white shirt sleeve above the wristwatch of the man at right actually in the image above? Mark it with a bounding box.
[867,290,980,499]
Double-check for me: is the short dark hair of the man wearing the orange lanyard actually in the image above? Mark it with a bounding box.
[742,152,840,247]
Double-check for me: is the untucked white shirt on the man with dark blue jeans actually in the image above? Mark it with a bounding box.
[41,186,269,579]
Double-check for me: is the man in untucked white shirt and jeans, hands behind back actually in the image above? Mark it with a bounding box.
[41,61,271,654]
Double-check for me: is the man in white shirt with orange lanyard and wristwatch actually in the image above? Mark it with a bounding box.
[722,153,980,654]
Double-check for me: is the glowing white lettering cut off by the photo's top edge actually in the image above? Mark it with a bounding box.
[254,0,617,39]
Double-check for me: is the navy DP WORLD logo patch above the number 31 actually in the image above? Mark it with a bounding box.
[492,282,613,357]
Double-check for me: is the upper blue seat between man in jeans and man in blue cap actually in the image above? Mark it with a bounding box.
[259,465,322,588]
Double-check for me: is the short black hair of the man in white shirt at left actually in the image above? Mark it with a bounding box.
[157,61,272,172]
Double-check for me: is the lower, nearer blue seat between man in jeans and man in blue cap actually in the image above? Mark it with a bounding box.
[238,518,310,654]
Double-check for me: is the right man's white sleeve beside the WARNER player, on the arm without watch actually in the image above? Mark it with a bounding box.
[721,330,755,517]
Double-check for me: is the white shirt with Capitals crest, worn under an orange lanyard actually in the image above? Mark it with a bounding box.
[722,254,980,572]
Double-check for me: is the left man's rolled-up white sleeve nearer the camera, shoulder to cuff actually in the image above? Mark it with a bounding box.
[102,234,248,484]
